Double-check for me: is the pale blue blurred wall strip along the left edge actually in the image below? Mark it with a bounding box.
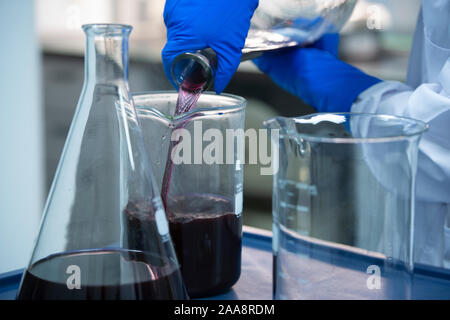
[0,0,42,273]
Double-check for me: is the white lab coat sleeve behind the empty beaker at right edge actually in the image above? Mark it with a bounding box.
[351,58,450,203]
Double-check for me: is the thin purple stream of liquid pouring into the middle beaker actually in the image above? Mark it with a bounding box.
[161,81,205,209]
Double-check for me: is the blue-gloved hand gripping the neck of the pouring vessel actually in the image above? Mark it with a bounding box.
[162,0,258,93]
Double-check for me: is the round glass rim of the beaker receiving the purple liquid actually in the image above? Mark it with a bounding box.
[131,90,247,122]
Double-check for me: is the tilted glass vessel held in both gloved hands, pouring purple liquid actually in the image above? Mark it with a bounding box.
[171,0,356,90]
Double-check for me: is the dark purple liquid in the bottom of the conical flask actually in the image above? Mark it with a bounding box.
[17,250,186,300]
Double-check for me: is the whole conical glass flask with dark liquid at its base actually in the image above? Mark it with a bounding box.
[18,24,187,299]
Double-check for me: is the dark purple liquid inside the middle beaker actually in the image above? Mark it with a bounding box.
[169,194,242,297]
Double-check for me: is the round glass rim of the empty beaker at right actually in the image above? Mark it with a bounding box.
[264,112,429,144]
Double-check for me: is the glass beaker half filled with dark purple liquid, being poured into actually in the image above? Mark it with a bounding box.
[134,92,246,297]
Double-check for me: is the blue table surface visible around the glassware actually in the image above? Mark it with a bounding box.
[0,227,450,300]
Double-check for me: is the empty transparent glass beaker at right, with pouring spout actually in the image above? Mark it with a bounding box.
[265,113,427,299]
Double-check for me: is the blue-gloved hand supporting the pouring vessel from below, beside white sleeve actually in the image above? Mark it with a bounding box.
[254,34,381,112]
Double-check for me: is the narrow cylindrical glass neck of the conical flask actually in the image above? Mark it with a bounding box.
[83,24,132,86]
